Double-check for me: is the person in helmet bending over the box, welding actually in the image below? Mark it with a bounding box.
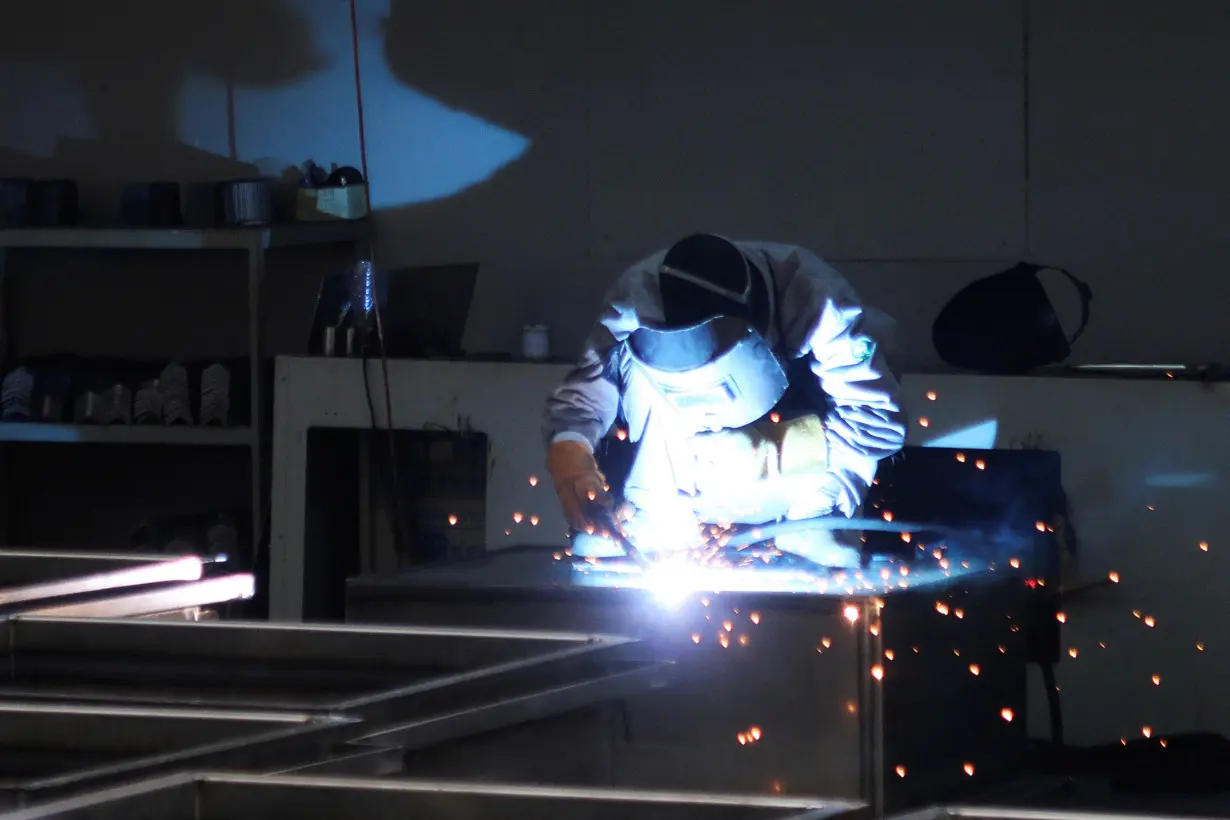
[544,234,905,567]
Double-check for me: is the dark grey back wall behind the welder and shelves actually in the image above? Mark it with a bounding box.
[0,0,1230,369]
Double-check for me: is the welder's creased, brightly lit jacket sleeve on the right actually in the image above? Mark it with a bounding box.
[779,248,905,515]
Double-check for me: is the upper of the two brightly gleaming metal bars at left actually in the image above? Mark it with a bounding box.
[0,550,203,612]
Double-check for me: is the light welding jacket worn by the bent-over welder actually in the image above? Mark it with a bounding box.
[544,241,905,521]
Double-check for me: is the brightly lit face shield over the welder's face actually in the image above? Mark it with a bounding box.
[629,316,788,430]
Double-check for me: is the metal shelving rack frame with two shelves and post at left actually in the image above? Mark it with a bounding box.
[0,220,370,556]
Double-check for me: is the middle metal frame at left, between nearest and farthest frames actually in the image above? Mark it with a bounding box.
[0,701,353,808]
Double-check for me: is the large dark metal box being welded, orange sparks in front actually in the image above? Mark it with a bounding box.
[348,547,1026,811]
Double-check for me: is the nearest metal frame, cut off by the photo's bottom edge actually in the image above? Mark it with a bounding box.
[5,775,867,820]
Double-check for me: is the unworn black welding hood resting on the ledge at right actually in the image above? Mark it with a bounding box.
[931,262,1093,375]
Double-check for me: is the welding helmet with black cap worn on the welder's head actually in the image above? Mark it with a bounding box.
[629,234,788,430]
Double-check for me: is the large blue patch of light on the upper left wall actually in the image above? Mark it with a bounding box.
[178,0,530,209]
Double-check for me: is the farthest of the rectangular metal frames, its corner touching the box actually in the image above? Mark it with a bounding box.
[0,618,656,725]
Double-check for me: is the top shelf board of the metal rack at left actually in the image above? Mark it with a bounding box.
[0,219,369,251]
